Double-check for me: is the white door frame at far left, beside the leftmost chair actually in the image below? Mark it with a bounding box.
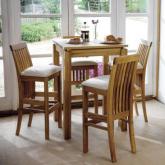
[0,0,20,110]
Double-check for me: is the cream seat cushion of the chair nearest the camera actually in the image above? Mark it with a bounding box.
[82,75,110,90]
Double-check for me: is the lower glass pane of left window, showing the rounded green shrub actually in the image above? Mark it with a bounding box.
[21,18,61,55]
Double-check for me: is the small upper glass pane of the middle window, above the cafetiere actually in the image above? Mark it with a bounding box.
[74,0,111,13]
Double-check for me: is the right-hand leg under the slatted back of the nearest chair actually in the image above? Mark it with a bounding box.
[128,117,136,153]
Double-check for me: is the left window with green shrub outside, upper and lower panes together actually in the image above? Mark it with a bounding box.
[20,0,61,55]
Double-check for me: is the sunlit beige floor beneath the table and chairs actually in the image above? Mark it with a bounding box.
[0,101,165,165]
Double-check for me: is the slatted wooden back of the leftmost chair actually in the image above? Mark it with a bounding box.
[10,42,32,76]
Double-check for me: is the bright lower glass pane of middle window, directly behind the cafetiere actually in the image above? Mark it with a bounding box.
[74,17,111,41]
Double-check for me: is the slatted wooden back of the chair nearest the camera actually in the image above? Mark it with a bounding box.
[107,55,139,119]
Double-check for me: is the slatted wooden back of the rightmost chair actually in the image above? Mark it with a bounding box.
[136,40,152,70]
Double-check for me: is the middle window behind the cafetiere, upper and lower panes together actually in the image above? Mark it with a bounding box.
[72,0,111,40]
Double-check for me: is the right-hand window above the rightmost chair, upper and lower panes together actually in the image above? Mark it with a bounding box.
[125,0,148,50]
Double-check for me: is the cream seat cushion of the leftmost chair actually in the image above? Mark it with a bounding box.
[21,65,61,77]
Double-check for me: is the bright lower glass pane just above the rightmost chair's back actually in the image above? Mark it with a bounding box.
[126,17,148,50]
